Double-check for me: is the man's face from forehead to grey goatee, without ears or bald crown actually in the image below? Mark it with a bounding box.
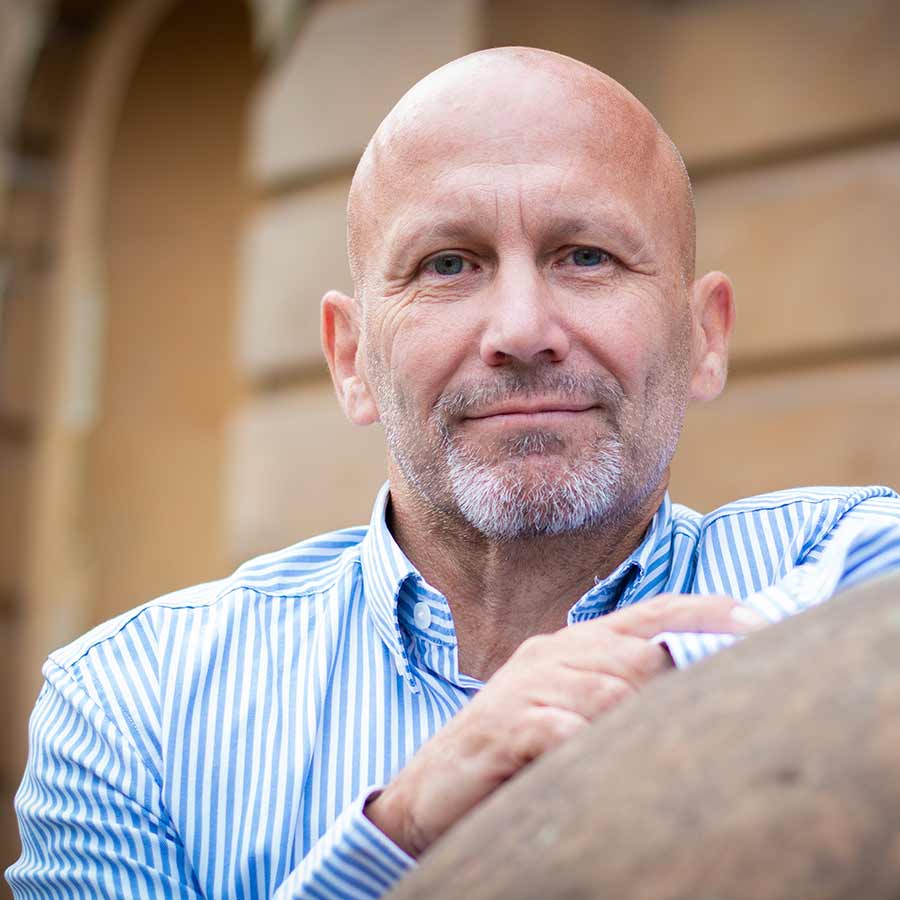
[362,67,692,539]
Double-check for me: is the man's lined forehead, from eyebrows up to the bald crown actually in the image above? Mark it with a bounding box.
[367,112,661,264]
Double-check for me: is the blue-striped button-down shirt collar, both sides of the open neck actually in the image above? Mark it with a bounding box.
[360,483,672,690]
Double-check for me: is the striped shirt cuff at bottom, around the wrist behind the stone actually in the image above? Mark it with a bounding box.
[273,786,416,900]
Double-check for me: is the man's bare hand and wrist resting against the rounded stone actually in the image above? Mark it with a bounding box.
[366,594,765,857]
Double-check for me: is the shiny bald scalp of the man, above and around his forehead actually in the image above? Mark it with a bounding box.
[347,47,695,296]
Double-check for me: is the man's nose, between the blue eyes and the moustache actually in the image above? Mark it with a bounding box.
[481,260,569,366]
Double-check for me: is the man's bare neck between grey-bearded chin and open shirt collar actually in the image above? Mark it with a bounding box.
[388,473,668,680]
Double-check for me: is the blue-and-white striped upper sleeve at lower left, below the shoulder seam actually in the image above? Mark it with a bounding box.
[6,660,202,900]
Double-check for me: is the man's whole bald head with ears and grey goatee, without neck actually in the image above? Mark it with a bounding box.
[323,48,732,539]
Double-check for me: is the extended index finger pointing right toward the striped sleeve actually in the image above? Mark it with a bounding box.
[594,594,768,639]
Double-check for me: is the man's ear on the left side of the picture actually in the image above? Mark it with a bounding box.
[322,291,378,425]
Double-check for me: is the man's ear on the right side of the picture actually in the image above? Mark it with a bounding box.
[690,272,734,400]
